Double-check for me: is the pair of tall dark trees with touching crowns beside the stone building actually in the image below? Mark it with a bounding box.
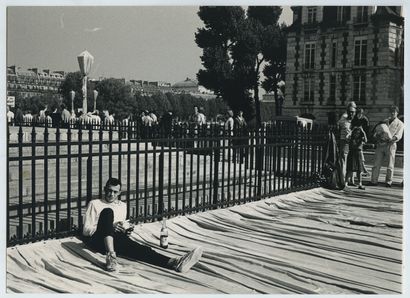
[195,6,286,126]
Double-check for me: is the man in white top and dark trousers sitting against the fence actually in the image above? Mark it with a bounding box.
[83,178,202,272]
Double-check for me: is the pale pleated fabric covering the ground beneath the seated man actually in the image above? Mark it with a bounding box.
[7,165,403,294]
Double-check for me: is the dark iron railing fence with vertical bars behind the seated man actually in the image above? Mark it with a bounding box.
[7,123,328,246]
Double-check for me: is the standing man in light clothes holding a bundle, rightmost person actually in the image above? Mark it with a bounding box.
[371,106,404,187]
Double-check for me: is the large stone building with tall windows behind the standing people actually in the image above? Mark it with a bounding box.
[283,6,404,124]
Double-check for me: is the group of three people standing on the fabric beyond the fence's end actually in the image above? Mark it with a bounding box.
[337,102,404,190]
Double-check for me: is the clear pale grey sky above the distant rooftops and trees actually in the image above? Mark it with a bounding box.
[6,6,292,84]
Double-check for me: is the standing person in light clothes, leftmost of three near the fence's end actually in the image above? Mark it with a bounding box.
[337,102,356,185]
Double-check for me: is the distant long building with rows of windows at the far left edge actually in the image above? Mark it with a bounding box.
[7,65,66,97]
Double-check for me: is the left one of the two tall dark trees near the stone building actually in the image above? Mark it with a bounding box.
[195,6,253,118]
